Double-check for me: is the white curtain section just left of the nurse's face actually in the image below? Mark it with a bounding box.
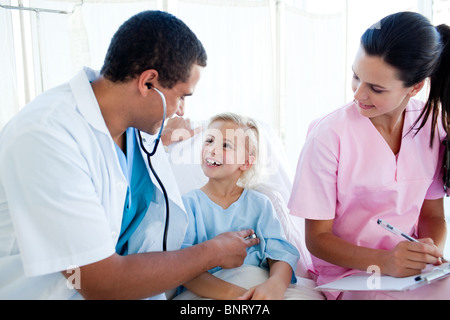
[283,0,347,168]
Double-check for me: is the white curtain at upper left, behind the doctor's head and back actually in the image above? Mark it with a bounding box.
[0,0,161,130]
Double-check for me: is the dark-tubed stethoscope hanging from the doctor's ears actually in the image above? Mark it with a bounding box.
[138,83,169,251]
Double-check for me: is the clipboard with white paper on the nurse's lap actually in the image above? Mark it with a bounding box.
[315,263,450,292]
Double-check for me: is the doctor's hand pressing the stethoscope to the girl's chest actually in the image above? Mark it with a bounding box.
[210,230,259,269]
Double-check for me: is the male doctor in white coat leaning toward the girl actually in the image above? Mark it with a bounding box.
[0,11,258,299]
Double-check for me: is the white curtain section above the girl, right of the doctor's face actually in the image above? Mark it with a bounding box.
[175,0,277,130]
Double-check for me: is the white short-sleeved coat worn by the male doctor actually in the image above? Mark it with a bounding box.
[0,68,188,299]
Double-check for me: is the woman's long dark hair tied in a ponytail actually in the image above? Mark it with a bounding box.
[361,12,450,145]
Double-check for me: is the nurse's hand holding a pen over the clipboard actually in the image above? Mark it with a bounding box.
[382,239,442,278]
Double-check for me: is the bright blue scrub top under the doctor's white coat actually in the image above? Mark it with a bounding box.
[115,128,154,255]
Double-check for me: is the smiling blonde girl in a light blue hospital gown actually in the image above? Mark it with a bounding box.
[179,113,299,300]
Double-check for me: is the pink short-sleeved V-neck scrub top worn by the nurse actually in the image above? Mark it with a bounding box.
[289,100,446,298]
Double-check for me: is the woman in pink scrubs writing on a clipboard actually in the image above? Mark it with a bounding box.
[289,12,450,299]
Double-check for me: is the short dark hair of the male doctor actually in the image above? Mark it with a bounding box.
[100,11,207,89]
